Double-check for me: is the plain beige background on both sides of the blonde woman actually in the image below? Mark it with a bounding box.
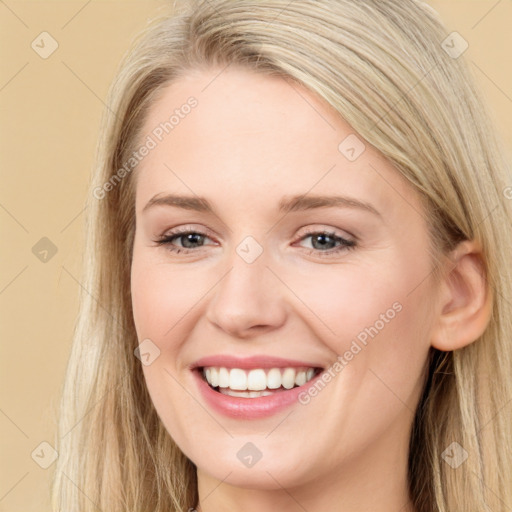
[0,0,512,512]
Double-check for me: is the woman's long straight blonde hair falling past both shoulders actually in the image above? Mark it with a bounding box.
[52,0,512,512]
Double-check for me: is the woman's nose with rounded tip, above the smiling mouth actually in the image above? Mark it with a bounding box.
[206,252,287,338]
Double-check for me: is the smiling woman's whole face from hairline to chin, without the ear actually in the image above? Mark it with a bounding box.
[131,67,436,489]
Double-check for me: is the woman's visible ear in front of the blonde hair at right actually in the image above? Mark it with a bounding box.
[432,241,492,351]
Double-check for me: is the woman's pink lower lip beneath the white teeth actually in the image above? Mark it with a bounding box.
[192,370,321,420]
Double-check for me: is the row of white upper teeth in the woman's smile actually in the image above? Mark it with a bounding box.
[203,366,315,391]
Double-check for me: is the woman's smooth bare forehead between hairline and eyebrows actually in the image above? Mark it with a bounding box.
[136,68,422,219]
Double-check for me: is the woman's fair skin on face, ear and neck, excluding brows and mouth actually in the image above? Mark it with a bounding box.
[131,66,490,512]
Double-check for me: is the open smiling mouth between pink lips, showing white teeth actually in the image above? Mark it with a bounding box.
[197,366,323,398]
